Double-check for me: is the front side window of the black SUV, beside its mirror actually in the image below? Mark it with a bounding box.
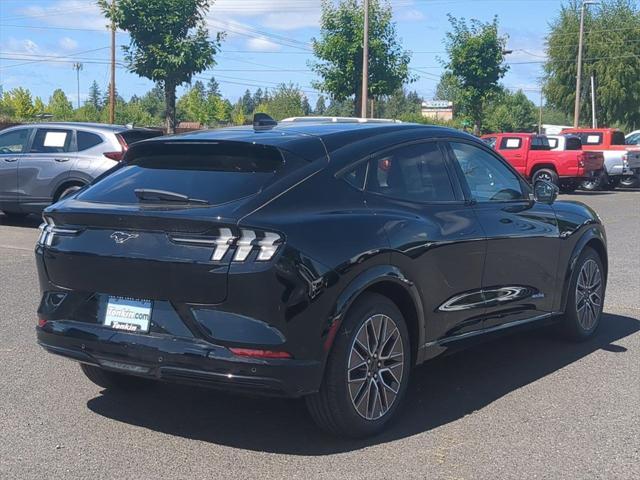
[450,142,524,202]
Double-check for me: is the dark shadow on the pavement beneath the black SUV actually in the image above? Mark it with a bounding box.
[86,314,640,455]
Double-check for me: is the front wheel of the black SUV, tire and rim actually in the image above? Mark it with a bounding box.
[560,247,606,341]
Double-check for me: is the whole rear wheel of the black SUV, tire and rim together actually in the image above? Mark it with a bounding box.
[306,293,411,438]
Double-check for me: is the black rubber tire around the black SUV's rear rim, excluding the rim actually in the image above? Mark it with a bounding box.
[322,294,411,437]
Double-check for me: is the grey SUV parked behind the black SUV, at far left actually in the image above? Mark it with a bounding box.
[0,122,162,217]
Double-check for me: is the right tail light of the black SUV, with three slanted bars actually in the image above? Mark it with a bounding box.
[171,228,283,262]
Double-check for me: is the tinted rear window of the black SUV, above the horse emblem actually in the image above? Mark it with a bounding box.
[78,142,296,205]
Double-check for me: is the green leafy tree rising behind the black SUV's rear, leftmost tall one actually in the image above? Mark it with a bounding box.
[99,0,224,133]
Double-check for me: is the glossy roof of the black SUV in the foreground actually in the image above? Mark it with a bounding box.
[154,121,478,159]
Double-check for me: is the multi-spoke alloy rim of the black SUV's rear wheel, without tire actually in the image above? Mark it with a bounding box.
[347,314,404,420]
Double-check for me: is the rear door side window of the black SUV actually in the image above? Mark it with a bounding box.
[367,142,456,202]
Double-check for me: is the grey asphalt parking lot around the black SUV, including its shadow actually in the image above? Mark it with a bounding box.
[0,190,640,479]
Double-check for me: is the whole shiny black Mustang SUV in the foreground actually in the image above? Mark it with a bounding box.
[36,117,608,436]
